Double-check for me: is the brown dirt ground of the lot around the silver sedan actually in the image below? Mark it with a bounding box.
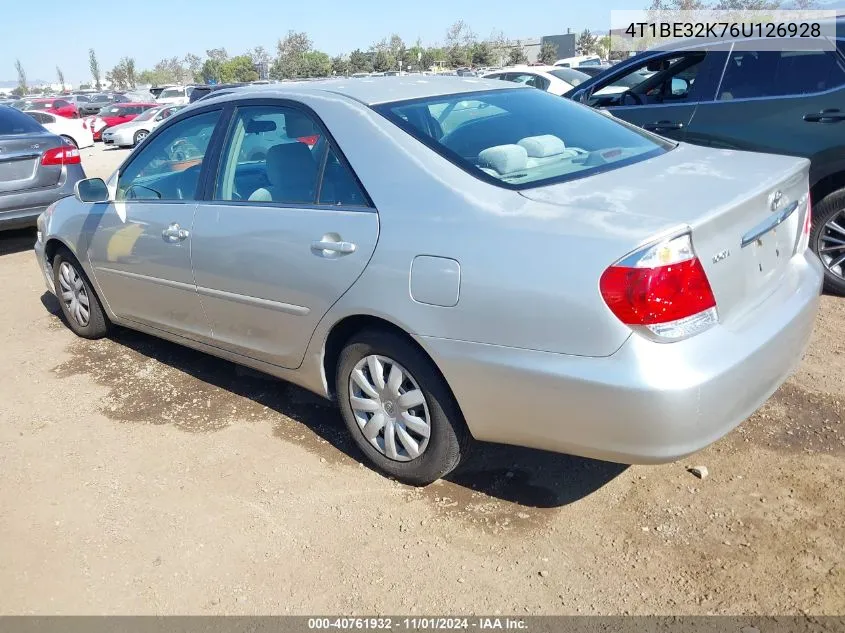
[0,147,845,615]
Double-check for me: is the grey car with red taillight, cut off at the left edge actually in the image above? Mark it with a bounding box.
[0,106,85,230]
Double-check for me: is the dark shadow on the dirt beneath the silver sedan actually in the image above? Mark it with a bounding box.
[41,293,627,508]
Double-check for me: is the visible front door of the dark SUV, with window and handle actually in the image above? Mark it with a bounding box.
[589,49,724,140]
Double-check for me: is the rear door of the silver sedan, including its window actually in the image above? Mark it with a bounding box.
[192,104,379,368]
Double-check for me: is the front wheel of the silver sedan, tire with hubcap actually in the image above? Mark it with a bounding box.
[53,249,110,339]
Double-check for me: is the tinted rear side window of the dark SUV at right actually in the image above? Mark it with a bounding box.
[718,44,845,101]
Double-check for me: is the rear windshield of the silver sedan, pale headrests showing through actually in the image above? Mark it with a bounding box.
[375,89,674,189]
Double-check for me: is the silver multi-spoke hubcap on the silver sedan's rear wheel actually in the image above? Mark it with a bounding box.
[349,355,431,462]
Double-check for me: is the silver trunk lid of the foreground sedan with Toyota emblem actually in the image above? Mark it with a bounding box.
[521,145,809,324]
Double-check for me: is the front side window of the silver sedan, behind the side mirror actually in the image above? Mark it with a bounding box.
[117,111,220,200]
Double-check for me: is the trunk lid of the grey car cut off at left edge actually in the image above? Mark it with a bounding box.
[0,133,63,194]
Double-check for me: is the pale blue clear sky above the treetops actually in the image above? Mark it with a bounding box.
[0,0,647,85]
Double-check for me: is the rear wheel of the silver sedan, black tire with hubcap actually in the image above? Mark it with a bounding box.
[335,330,470,486]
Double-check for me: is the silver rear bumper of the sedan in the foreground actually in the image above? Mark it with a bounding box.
[418,251,822,464]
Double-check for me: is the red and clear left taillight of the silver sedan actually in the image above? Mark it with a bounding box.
[599,234,717,340]
